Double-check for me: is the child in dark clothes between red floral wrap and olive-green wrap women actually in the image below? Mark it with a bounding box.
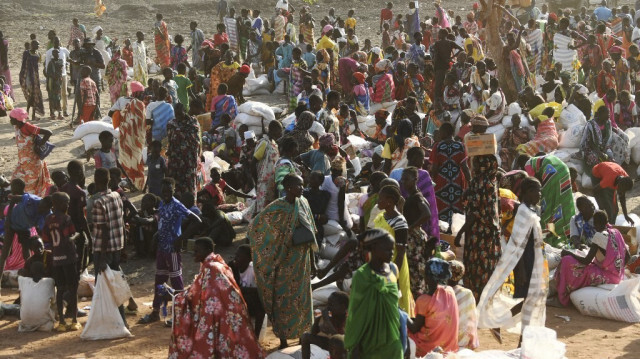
[229,244,265,338]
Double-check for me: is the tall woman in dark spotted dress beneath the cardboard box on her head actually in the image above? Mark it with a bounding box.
[455,155,500,301]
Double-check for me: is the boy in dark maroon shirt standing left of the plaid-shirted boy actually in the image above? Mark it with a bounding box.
[42,192,82,332]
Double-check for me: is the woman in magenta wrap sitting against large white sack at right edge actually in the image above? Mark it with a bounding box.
[555,211,629,306]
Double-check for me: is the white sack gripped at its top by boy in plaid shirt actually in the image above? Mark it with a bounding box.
[80,267,132,340]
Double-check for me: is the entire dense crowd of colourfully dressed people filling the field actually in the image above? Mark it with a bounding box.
[0,0,640,358]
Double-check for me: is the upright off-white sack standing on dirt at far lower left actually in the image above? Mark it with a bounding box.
[18,277,55,332]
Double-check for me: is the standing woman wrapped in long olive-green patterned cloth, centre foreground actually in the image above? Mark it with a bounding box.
[247,174,317,348]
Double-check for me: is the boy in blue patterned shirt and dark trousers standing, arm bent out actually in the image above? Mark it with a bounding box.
[139,178,202,324]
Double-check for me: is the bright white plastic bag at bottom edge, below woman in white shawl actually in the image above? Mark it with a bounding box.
[520,326,567,359]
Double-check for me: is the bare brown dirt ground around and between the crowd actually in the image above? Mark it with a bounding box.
[0,0,640,359]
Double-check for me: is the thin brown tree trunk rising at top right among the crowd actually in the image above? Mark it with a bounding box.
[481,0,518,102]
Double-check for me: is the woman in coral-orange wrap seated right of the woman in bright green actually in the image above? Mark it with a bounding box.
[407,258,459,357]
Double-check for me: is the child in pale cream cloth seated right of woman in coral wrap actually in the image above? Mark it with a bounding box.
[448,260,480,350]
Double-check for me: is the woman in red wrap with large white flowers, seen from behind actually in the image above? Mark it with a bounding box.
[169,238,264,358]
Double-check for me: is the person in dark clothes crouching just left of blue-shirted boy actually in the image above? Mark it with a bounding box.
[129,193,159,258]
